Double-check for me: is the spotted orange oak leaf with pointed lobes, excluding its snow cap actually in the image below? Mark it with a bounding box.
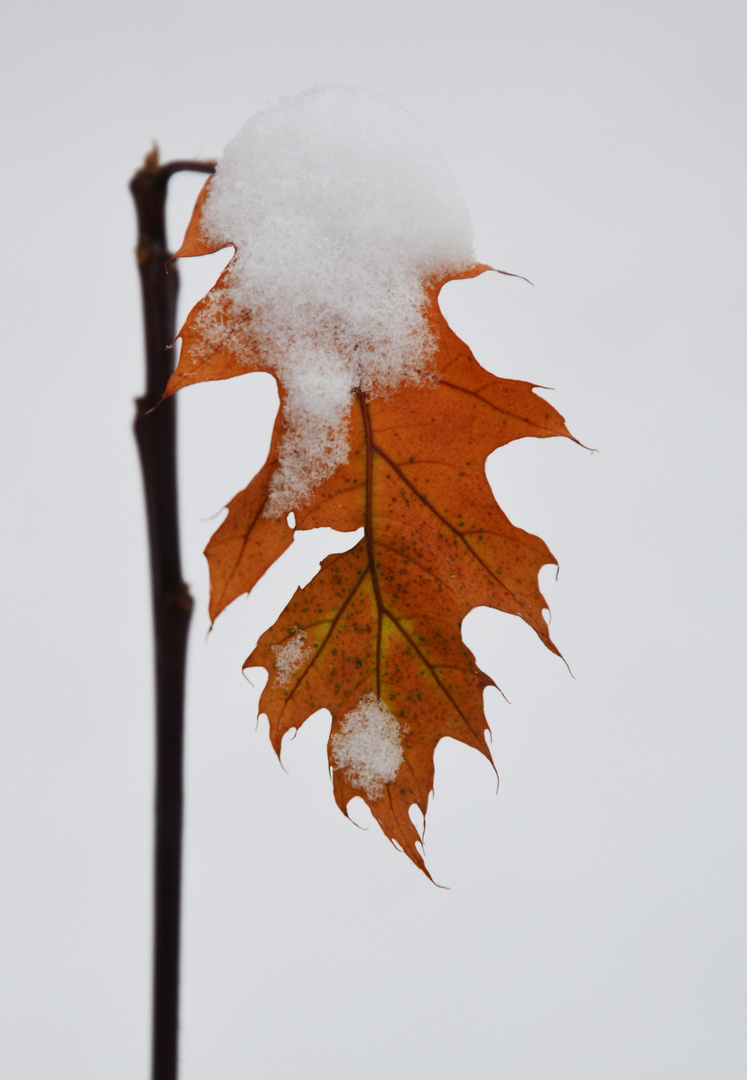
[165,180,572,877]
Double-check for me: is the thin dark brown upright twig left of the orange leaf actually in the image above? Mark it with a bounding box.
[130,149,215,1080]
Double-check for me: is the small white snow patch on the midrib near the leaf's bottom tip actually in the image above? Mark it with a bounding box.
[330,693,405,799]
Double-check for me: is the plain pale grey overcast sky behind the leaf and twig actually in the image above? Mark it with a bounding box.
[0,0,747,1080]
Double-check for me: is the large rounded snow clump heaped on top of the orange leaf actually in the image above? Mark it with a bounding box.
[198,86,475,517]
